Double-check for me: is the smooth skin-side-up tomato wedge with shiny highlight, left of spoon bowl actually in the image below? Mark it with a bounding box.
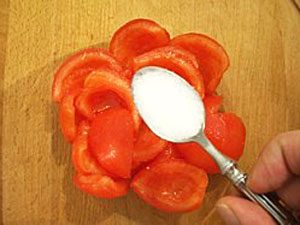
[88,108,134,178]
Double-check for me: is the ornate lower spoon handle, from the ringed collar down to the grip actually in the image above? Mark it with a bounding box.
[224,161,299,225]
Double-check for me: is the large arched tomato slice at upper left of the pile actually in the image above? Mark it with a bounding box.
[52,48,128,102]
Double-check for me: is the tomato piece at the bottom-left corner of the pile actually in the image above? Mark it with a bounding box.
[73,173,129,199]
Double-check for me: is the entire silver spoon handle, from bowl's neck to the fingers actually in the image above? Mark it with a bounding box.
[192,134,300,225]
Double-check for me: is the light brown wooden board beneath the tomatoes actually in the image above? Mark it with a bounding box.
[0,0,300,225]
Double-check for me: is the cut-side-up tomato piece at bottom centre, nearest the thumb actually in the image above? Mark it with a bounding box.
[131,160,208,212]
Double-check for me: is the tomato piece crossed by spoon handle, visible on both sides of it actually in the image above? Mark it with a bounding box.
[176,113,246,174]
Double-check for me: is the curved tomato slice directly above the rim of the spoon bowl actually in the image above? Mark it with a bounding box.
[133,46,204,97]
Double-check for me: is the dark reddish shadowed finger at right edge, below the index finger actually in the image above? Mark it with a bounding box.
[277,178,300,210]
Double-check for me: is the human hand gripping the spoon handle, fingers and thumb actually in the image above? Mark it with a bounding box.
[217,130,300,225]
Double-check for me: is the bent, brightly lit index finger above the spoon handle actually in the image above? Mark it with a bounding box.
[248,130,300,193]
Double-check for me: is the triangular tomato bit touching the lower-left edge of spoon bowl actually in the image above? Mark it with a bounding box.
[133,123,168,164]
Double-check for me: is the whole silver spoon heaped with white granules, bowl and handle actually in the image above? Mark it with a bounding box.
[132,66,297,225]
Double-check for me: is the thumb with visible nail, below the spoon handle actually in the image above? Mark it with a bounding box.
[216,196,276,225]
